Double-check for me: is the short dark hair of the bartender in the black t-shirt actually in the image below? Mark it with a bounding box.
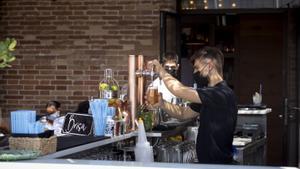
[191,46,224,75]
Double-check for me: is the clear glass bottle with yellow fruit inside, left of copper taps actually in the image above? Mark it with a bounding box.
[99,69,119,99]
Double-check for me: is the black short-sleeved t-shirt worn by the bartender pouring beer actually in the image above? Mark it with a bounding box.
[190,81,237,164]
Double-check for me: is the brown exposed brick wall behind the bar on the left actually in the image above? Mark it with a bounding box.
[0,0,176,116]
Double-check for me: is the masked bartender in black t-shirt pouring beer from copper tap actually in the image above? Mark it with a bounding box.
[148,47,237,164]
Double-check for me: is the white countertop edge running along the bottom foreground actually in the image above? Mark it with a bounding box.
[0,159,296,169]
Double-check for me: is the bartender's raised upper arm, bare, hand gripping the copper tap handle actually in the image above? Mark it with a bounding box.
[149,60,201,103]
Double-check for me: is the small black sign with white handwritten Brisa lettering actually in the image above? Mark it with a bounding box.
[62,113,93,136]
